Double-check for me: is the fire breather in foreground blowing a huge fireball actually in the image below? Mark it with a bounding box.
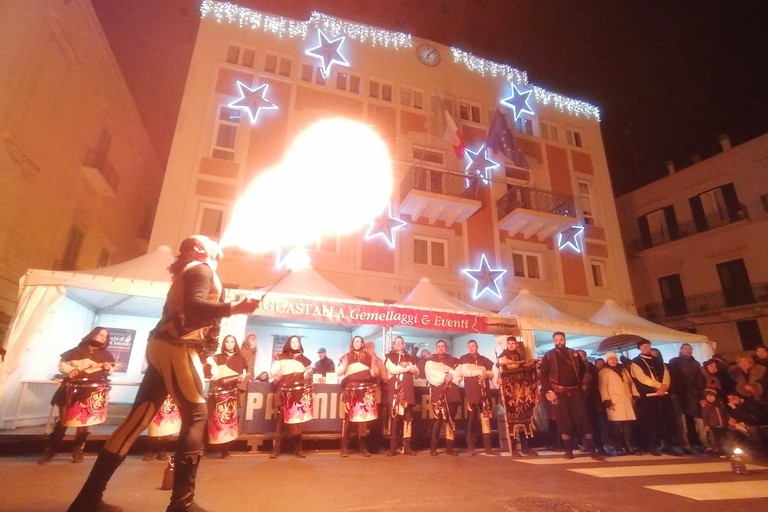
[69,235,259,512]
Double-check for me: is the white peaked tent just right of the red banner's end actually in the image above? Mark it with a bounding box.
[499,289,614,357]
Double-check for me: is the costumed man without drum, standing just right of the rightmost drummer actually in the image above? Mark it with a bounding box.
[385,336,419,457]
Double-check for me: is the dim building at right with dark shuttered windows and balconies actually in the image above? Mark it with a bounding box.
[616,135,768,356]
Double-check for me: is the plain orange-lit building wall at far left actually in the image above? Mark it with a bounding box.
[0,0,162,334]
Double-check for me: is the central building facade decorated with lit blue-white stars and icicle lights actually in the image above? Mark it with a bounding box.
[150,0,634,324]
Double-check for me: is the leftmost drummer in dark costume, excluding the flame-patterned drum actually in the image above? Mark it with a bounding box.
[37,327,115,464]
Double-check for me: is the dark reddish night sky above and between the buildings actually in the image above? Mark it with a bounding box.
[92,0,768,196]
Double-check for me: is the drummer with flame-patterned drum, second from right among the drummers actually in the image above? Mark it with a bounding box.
[269,336,312,459]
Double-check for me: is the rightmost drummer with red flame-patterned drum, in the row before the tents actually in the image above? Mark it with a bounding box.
[336,336,378,457]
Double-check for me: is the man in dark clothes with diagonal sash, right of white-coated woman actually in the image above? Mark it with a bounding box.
[630,339,682,455]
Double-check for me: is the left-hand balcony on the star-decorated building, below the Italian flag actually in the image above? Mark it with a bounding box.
[400,166,481,226]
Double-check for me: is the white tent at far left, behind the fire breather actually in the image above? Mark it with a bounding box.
[0,246,174,427]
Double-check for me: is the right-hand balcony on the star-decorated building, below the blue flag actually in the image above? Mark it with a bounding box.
[496,186,576,241]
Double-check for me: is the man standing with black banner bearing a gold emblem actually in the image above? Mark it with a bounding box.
[496,336,539,457]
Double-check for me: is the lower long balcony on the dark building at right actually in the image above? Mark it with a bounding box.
[645,283,768,322]
